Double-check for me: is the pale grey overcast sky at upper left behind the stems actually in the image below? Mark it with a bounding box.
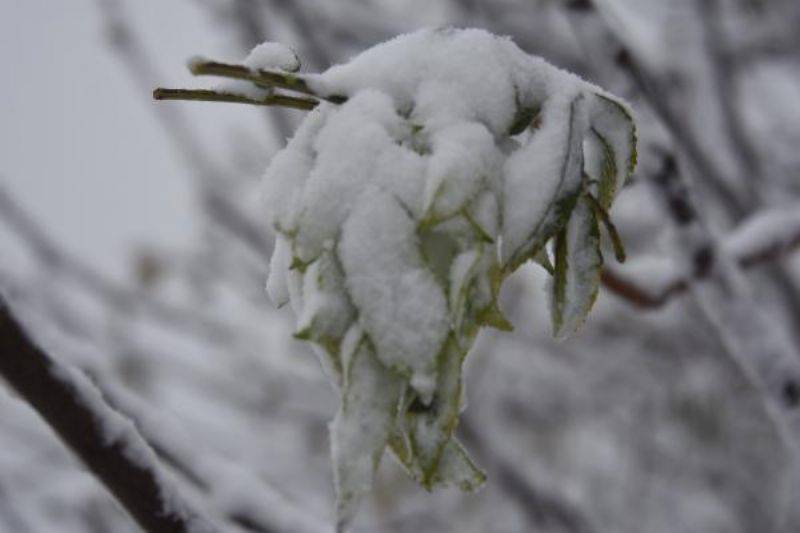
[0,0,271,275]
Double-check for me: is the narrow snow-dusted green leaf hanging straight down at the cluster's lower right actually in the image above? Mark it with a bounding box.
[551,195,603,338]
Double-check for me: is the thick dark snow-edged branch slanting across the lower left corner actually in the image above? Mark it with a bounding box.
[0,295,217,533]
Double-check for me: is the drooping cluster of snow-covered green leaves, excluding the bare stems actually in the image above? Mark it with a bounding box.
[256,29,635,530]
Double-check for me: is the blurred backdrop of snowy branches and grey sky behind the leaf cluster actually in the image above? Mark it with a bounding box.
[0,0,800,533]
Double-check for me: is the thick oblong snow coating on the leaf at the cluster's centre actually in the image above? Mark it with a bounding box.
[339,188,448,401]
